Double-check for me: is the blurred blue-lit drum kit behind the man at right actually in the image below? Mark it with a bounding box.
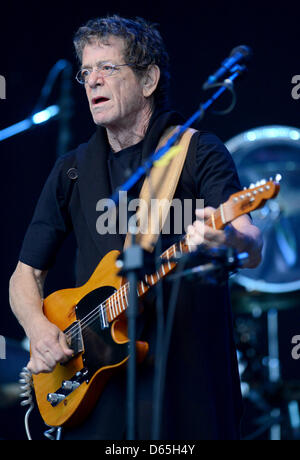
[226,125,300,439]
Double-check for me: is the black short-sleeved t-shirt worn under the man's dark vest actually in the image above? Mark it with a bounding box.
[20,132,241,284]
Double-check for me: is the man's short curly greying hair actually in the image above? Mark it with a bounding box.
[73,15,170,108]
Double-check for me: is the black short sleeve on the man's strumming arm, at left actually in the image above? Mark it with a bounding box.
[19,157,72,270]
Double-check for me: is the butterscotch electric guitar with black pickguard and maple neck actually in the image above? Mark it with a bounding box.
[33,179,280,427]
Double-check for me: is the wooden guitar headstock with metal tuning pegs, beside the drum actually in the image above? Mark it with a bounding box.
[227,174,281,220]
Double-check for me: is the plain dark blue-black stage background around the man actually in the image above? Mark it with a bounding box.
[0,0,300,439]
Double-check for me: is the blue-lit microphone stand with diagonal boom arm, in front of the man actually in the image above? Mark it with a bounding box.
[111,65,246,440]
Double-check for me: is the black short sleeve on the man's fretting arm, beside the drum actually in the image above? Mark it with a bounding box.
[195,132,241,208]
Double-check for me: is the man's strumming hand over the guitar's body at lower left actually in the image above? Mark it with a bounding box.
[27,317,73,374]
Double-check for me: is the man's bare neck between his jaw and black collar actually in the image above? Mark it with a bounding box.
[106,107,152,152]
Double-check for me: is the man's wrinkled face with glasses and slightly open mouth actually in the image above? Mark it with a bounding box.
[82,36,146,129]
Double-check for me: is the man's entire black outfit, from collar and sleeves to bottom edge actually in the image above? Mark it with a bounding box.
[20,112,241,440]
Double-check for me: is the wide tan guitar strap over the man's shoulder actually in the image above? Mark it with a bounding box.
[124,126,196,252]
